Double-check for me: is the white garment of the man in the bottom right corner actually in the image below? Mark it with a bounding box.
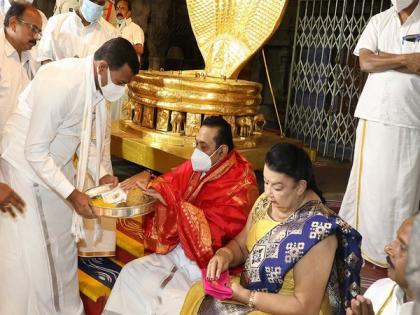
[363,278,414,315]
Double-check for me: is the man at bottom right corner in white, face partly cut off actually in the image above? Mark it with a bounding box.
[346,216,415,315]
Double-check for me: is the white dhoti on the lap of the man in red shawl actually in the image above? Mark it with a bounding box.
[103,245,201,315]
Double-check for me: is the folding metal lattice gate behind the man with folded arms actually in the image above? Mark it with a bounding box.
[286,0,390,160]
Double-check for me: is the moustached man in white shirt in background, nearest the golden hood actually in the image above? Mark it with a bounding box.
[114,0,144,58]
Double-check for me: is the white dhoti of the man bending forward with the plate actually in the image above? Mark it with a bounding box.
[0,159,84,315]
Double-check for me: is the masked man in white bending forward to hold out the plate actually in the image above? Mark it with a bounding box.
[0,38,139,315]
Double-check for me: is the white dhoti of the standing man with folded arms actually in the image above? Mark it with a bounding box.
[340,119,420,267]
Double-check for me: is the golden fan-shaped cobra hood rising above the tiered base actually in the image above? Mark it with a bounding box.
[187,0,288,78]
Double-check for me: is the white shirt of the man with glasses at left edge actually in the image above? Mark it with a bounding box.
[0,28,38,153]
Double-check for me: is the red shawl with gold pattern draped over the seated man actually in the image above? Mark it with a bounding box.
[143,150,258,268]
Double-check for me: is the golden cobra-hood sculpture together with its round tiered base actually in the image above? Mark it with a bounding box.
[113,0,310,170]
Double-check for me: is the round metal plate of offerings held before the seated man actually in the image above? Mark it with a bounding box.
[86,184,156,218]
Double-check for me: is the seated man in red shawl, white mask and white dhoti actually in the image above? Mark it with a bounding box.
[104,116,258,315]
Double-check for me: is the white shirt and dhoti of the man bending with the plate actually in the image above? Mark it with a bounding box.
[0,58,106,315]
